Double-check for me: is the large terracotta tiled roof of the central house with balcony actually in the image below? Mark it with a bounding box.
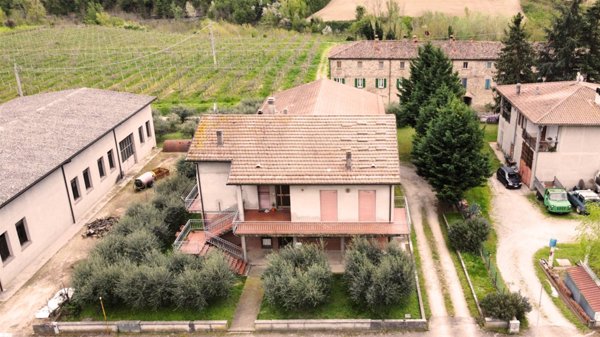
[187,114,400,185]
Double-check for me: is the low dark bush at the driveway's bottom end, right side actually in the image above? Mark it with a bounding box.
[480,292,531,321]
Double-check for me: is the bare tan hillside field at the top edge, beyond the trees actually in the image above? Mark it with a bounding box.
[313,0,521,21]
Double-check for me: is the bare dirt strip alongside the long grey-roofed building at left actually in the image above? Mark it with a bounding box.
[0,153,181,337]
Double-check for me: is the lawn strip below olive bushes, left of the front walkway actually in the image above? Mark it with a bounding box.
[61,277,246,322]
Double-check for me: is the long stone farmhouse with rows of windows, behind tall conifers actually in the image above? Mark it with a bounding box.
[329,40,502,108]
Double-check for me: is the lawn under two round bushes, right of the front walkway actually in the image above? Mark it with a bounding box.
[258,274,421,319]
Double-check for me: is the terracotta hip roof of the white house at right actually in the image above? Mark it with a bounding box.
[497,81,600,125]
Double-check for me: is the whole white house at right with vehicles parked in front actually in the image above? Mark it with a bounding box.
[497,81,600,188]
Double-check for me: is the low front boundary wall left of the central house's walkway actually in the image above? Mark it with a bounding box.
[33,321,227,335]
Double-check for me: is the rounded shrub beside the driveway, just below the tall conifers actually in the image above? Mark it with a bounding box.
[448,217,490,252]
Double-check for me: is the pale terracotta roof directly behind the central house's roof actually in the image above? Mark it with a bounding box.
[260,79,385,115]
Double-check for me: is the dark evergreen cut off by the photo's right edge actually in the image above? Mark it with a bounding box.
[581,0,600,82]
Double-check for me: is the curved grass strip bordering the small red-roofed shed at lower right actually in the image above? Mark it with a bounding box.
[533,244,589,332]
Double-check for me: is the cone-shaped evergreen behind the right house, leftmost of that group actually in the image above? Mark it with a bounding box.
[494,13,536,84]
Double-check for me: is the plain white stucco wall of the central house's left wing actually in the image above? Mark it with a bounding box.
[196,162,238,212]
